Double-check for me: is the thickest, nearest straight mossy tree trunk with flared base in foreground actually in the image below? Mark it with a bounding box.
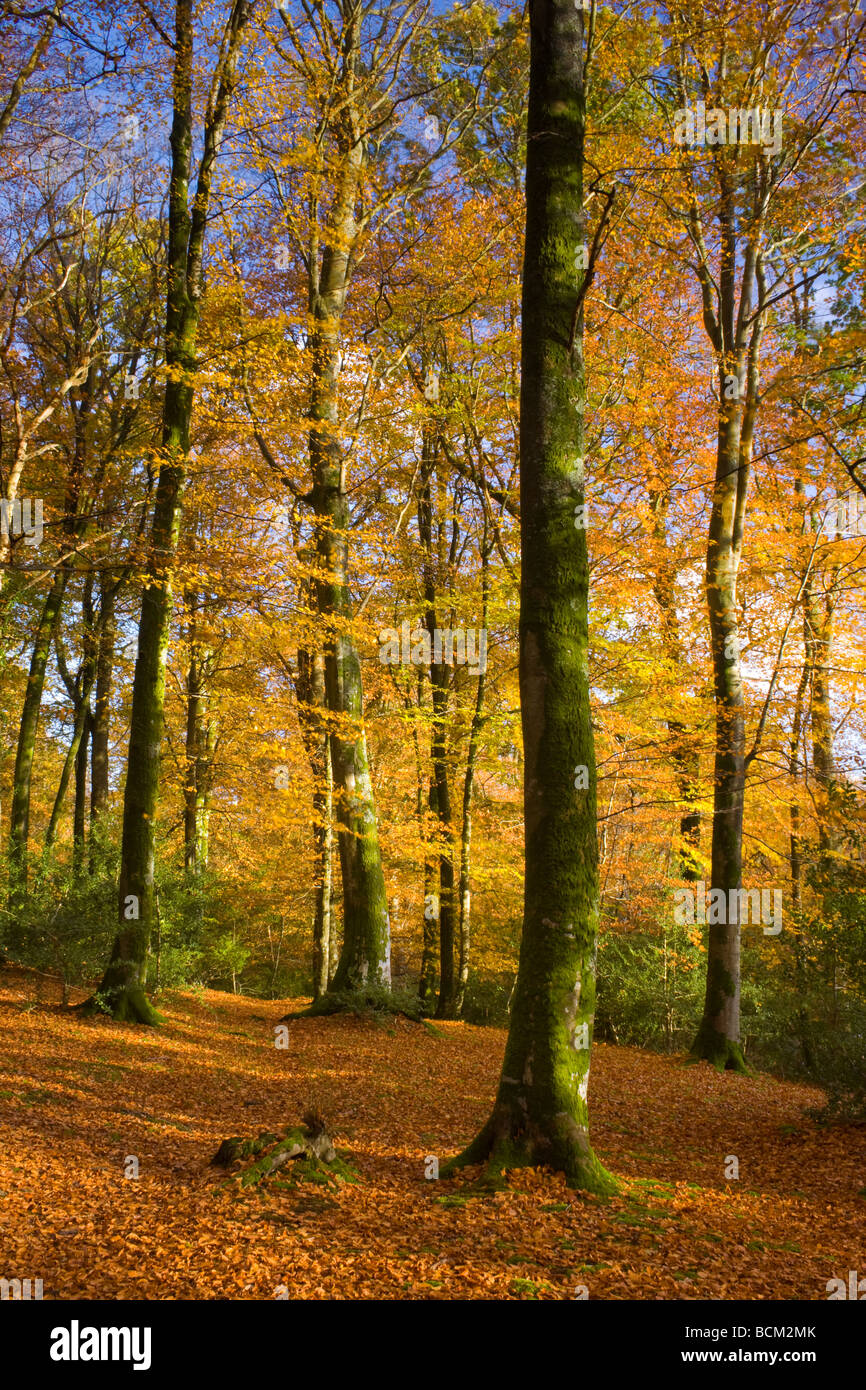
[446,0,614,1193]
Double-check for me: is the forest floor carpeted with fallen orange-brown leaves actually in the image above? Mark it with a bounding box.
[0,969,866,1300]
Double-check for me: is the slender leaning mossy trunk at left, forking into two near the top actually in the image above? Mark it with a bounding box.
[86,0,252,1023]
